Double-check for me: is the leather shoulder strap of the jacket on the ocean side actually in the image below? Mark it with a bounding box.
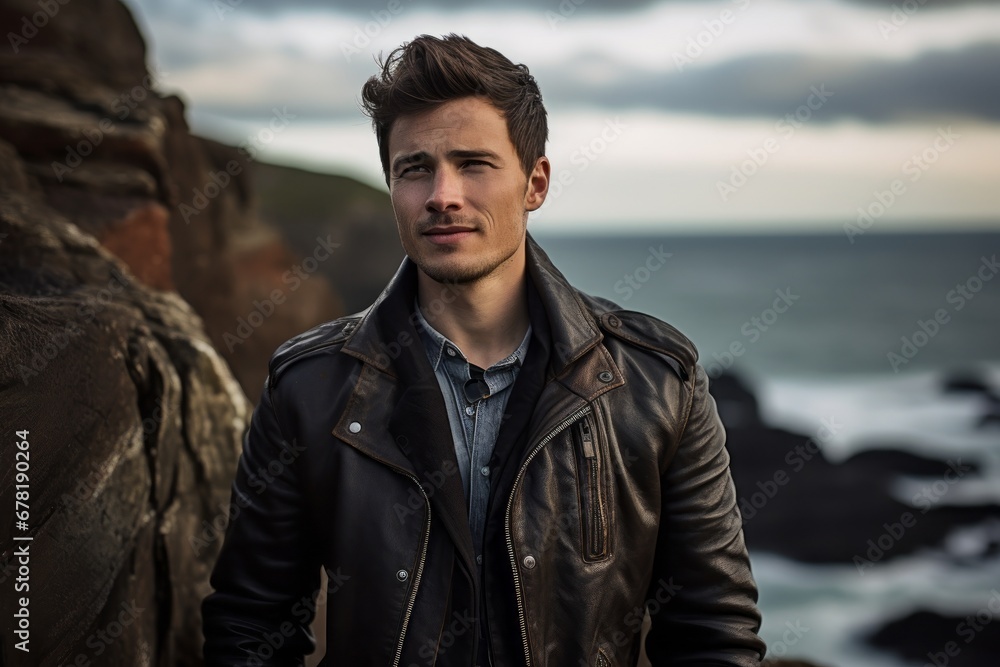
[579,292,698,381]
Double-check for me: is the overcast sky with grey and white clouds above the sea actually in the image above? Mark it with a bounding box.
[119,0,1000,233]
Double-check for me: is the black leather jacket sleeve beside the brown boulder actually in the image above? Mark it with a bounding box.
[202,384,320,665]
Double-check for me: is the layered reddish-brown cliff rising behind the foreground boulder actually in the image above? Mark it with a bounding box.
[0,0,346,401]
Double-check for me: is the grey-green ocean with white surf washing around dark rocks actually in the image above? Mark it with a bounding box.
[535,233,1000,667]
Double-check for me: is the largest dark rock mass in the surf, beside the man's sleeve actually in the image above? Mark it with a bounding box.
[713,378,1000,574]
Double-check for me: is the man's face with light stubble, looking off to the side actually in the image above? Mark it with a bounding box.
[389,97,549,283]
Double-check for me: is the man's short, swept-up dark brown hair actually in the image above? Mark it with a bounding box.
[361,34,549,183]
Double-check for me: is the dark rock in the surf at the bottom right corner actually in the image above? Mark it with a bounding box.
[867,608,1000,667]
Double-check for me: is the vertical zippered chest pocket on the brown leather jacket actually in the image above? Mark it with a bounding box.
[574,413,611,561]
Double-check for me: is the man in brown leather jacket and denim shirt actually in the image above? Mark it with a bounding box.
[204,35,764,667]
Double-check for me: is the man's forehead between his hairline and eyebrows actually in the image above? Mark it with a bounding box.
[389,97,514,160]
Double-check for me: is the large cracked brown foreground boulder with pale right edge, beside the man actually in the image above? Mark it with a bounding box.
[0,163,250,666]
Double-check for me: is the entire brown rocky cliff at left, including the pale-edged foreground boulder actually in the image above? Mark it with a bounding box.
[0,0,343,665]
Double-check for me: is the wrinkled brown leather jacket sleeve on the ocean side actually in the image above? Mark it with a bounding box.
[646,366,765,667]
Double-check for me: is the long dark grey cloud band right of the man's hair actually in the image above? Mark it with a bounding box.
[538,43,1000,123]
